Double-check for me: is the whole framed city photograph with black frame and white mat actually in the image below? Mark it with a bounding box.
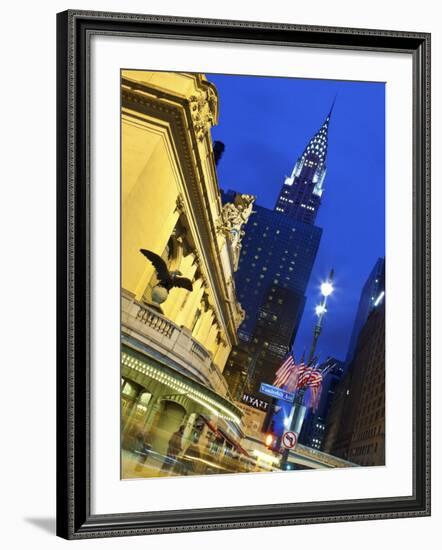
[57,11,430,539]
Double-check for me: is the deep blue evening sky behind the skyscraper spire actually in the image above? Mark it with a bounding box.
[206,74,385,366]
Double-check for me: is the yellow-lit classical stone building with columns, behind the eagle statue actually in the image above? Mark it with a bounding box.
[121,70,253,470]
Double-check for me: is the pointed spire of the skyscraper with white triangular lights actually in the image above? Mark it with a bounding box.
[275,101,335,224]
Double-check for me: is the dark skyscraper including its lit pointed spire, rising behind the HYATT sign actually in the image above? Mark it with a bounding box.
[223,105,331,393]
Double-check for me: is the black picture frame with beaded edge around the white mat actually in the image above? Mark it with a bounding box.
[57,10,430,539]
